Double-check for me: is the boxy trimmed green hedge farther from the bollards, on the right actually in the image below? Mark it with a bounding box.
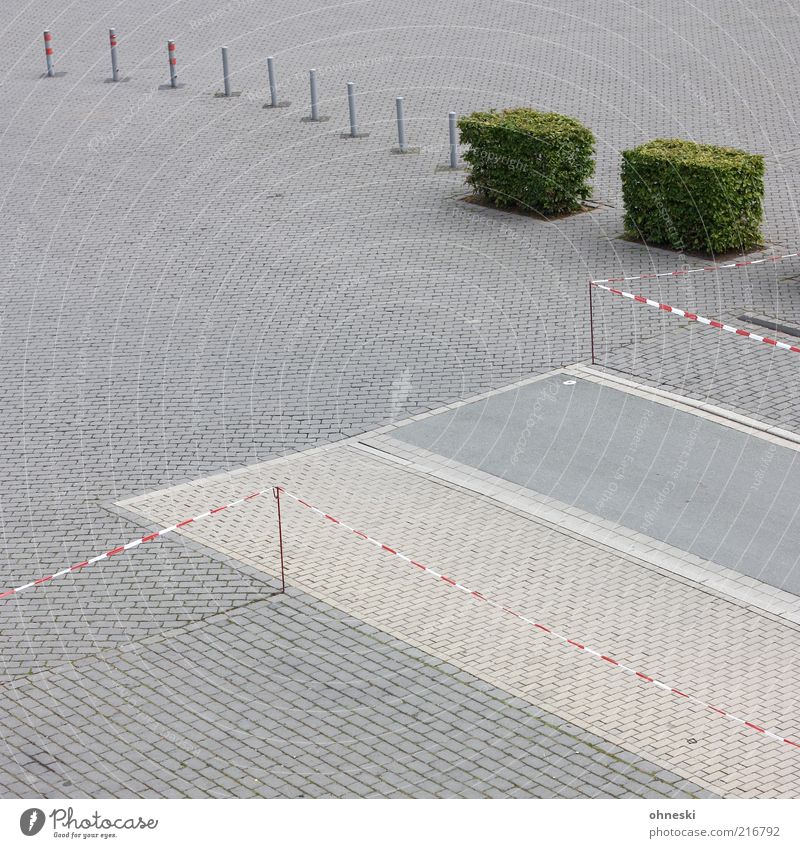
[622,139,764,253]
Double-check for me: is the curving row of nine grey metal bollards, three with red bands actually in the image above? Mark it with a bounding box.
[44,28,466,170]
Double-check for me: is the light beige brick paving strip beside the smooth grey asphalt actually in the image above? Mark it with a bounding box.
[120,444,800,798]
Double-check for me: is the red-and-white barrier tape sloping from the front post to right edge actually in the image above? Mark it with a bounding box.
[281,488,800,749]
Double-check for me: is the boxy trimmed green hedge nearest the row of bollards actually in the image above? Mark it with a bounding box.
[458,109,594,215]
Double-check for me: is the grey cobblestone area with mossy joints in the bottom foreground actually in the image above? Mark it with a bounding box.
[0,591,710,798]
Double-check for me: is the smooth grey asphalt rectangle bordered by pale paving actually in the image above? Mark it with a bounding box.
[394,375,800,594]
